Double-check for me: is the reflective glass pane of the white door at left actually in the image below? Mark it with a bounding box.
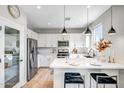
[4,26,20,88]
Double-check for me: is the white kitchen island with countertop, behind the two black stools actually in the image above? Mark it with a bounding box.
[50,56,124,88]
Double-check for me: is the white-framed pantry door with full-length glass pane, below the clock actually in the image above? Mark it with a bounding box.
[0,18,24,88]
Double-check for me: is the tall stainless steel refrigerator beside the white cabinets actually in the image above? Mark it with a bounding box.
[27,38,38,81]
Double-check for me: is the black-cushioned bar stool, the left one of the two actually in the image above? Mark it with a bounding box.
[64,72,85,88]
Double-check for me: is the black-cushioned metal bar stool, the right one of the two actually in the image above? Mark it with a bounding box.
[90,73,118,88]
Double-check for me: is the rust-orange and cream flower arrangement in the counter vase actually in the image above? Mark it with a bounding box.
[96,39,112,52]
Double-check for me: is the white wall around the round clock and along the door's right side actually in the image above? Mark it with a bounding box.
[0,5,27,86]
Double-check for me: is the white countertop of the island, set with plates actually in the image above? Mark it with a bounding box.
[50,54,124,69]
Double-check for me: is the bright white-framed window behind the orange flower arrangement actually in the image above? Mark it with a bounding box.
[91,24,103,49]
